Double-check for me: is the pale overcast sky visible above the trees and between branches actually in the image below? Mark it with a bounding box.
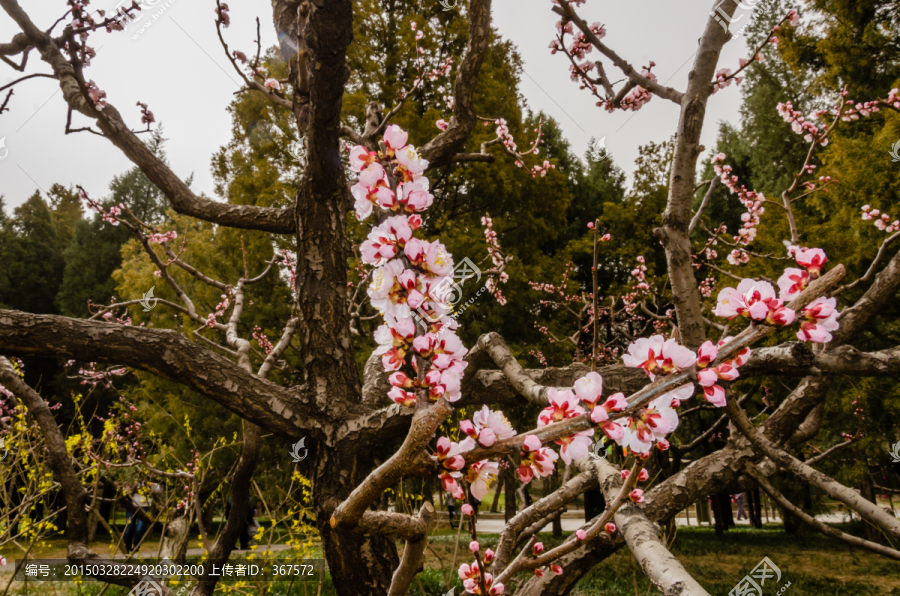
[0,0,749,209]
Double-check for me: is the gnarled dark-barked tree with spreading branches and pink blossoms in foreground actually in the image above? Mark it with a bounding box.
[0,0,900,596]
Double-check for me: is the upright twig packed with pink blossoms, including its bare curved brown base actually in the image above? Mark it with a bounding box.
[331,125,484,527]
